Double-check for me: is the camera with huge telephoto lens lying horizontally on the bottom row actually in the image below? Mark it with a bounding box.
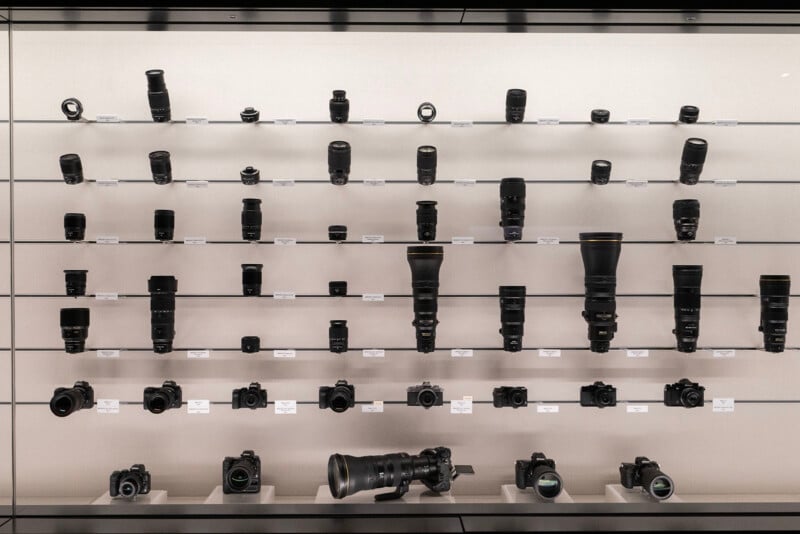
[328,447,458,501]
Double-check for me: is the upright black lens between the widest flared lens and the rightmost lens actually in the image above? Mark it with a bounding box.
[672,265,703,352]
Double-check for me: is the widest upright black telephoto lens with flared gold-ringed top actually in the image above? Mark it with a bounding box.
[580,232,622,352]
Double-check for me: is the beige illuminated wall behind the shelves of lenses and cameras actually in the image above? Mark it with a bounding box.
[6,31,800,502]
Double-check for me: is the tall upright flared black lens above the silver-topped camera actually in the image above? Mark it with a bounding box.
[406,246,444,353]
